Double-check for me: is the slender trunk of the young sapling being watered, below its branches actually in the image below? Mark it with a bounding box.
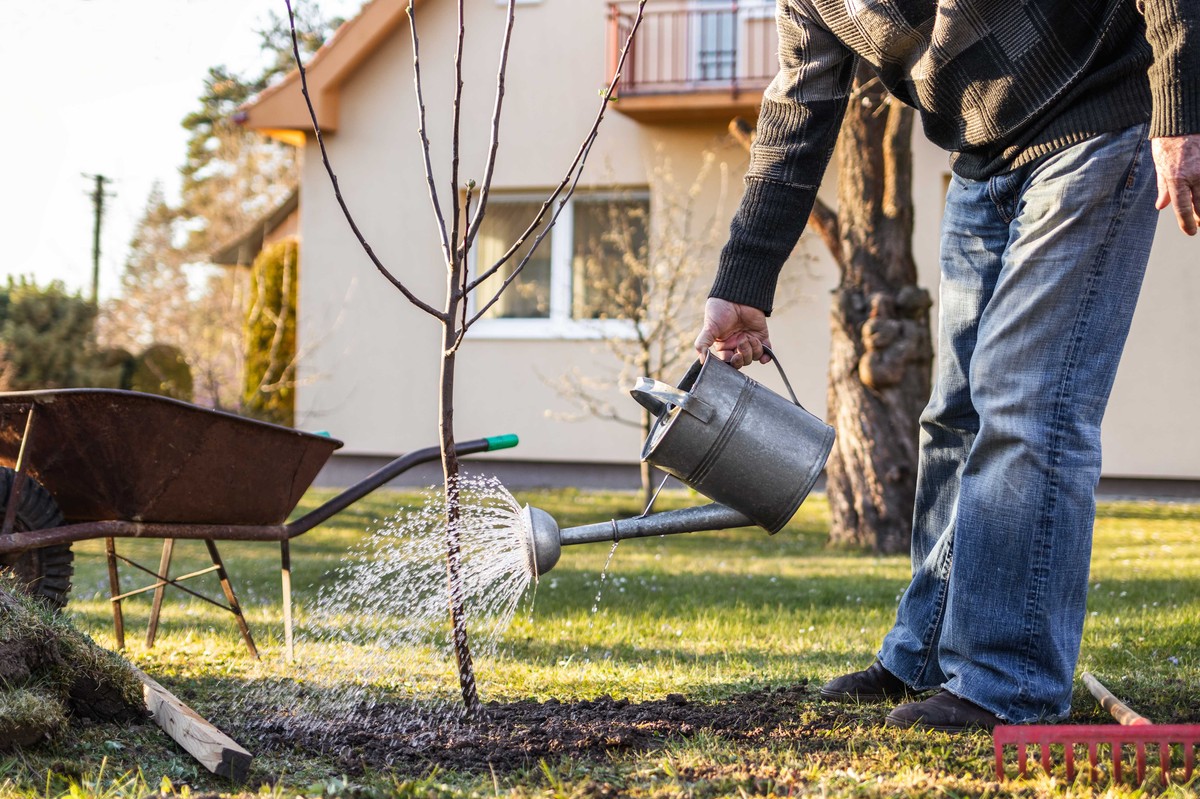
[439,314,479,716]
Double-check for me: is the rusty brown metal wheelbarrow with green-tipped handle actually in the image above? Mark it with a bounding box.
[0,389,517,659]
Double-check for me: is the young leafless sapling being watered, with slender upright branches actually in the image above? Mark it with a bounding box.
[284,0,646,714]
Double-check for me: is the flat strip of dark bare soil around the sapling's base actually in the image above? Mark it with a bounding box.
[259,683,854,774]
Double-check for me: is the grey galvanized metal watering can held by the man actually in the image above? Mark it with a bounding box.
[523,349,834,576]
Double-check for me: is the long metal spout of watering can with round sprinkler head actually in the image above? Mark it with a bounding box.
[522,503,754,577]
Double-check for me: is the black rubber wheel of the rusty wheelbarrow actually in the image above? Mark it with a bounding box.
[0,467,74,609]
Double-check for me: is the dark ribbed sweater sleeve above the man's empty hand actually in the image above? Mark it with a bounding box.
[1139,0,1200,137]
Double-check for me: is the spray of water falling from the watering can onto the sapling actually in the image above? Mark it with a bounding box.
[230,477,535,739]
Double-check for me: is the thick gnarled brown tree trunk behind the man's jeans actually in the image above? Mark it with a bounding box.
[814,67,932,553]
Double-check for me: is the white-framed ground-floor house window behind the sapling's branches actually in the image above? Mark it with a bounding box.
[474,192,649,337]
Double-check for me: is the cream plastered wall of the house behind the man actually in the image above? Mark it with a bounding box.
[298,0,1200,477]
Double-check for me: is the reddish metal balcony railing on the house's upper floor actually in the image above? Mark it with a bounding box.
[608,0,779,98]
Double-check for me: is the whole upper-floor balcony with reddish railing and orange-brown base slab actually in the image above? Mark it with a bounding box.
[608,0,779,122]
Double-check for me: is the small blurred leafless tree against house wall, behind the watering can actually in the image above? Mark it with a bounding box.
[547,150,728,505]
